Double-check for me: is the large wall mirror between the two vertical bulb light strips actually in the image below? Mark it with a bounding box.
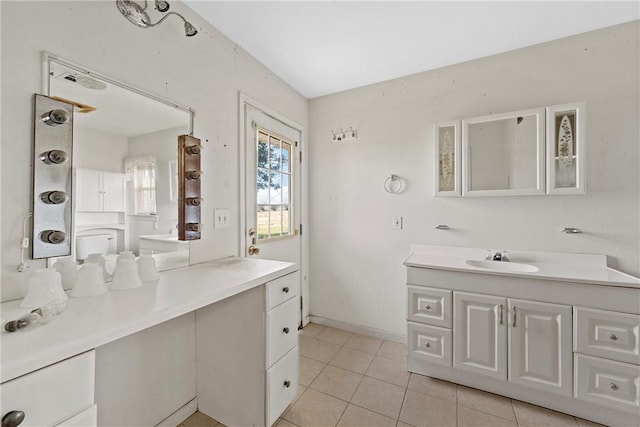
[43,52,193,269]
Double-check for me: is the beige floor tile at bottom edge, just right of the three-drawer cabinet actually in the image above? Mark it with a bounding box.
[282,389,347,427]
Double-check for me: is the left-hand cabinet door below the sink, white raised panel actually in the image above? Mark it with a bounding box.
[453,292,507,380]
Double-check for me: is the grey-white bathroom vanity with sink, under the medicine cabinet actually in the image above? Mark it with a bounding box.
[404,245,640,426]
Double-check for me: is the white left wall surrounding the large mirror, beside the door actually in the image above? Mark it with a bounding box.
[0,1,307,300]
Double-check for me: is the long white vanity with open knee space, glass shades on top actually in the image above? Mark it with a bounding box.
[0,258,298,426]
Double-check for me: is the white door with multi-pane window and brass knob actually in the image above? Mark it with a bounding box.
[241,103,302,320]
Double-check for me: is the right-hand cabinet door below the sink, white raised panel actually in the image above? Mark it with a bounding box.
[509,299,572,396]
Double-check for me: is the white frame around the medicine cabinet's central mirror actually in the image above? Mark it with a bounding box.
[461,108,545,197]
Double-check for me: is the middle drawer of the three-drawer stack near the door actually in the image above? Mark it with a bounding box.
[266,299,298,368]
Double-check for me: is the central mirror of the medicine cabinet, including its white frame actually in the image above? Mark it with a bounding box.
[462,108,545,197]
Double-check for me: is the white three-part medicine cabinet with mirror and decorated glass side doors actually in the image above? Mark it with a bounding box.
[434,103,586,197]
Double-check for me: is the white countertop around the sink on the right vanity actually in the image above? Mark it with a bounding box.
[404,245,640,288]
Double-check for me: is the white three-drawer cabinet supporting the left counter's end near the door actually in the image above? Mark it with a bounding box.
[196,272,300,426]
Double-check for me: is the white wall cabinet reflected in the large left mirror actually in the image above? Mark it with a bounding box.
[75,169,126,212]
